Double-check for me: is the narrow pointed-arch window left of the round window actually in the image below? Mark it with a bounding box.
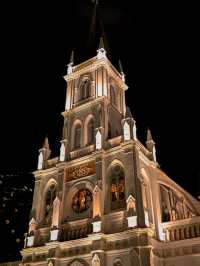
[44,183,56,224]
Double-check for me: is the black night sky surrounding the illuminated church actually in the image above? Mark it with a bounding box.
[0,0,200,261]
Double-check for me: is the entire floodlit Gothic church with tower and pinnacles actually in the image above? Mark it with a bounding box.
[21,43,200,266]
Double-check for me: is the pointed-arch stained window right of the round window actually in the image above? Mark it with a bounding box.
[110,164,126,210]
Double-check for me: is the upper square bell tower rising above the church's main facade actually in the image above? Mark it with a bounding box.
[63,38,128,158]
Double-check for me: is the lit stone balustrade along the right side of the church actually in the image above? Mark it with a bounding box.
[163,217,200,241]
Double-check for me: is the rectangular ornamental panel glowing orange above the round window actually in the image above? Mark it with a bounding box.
[65,161,96,181]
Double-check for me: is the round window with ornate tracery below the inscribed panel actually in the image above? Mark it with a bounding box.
[72,189,92,213]
